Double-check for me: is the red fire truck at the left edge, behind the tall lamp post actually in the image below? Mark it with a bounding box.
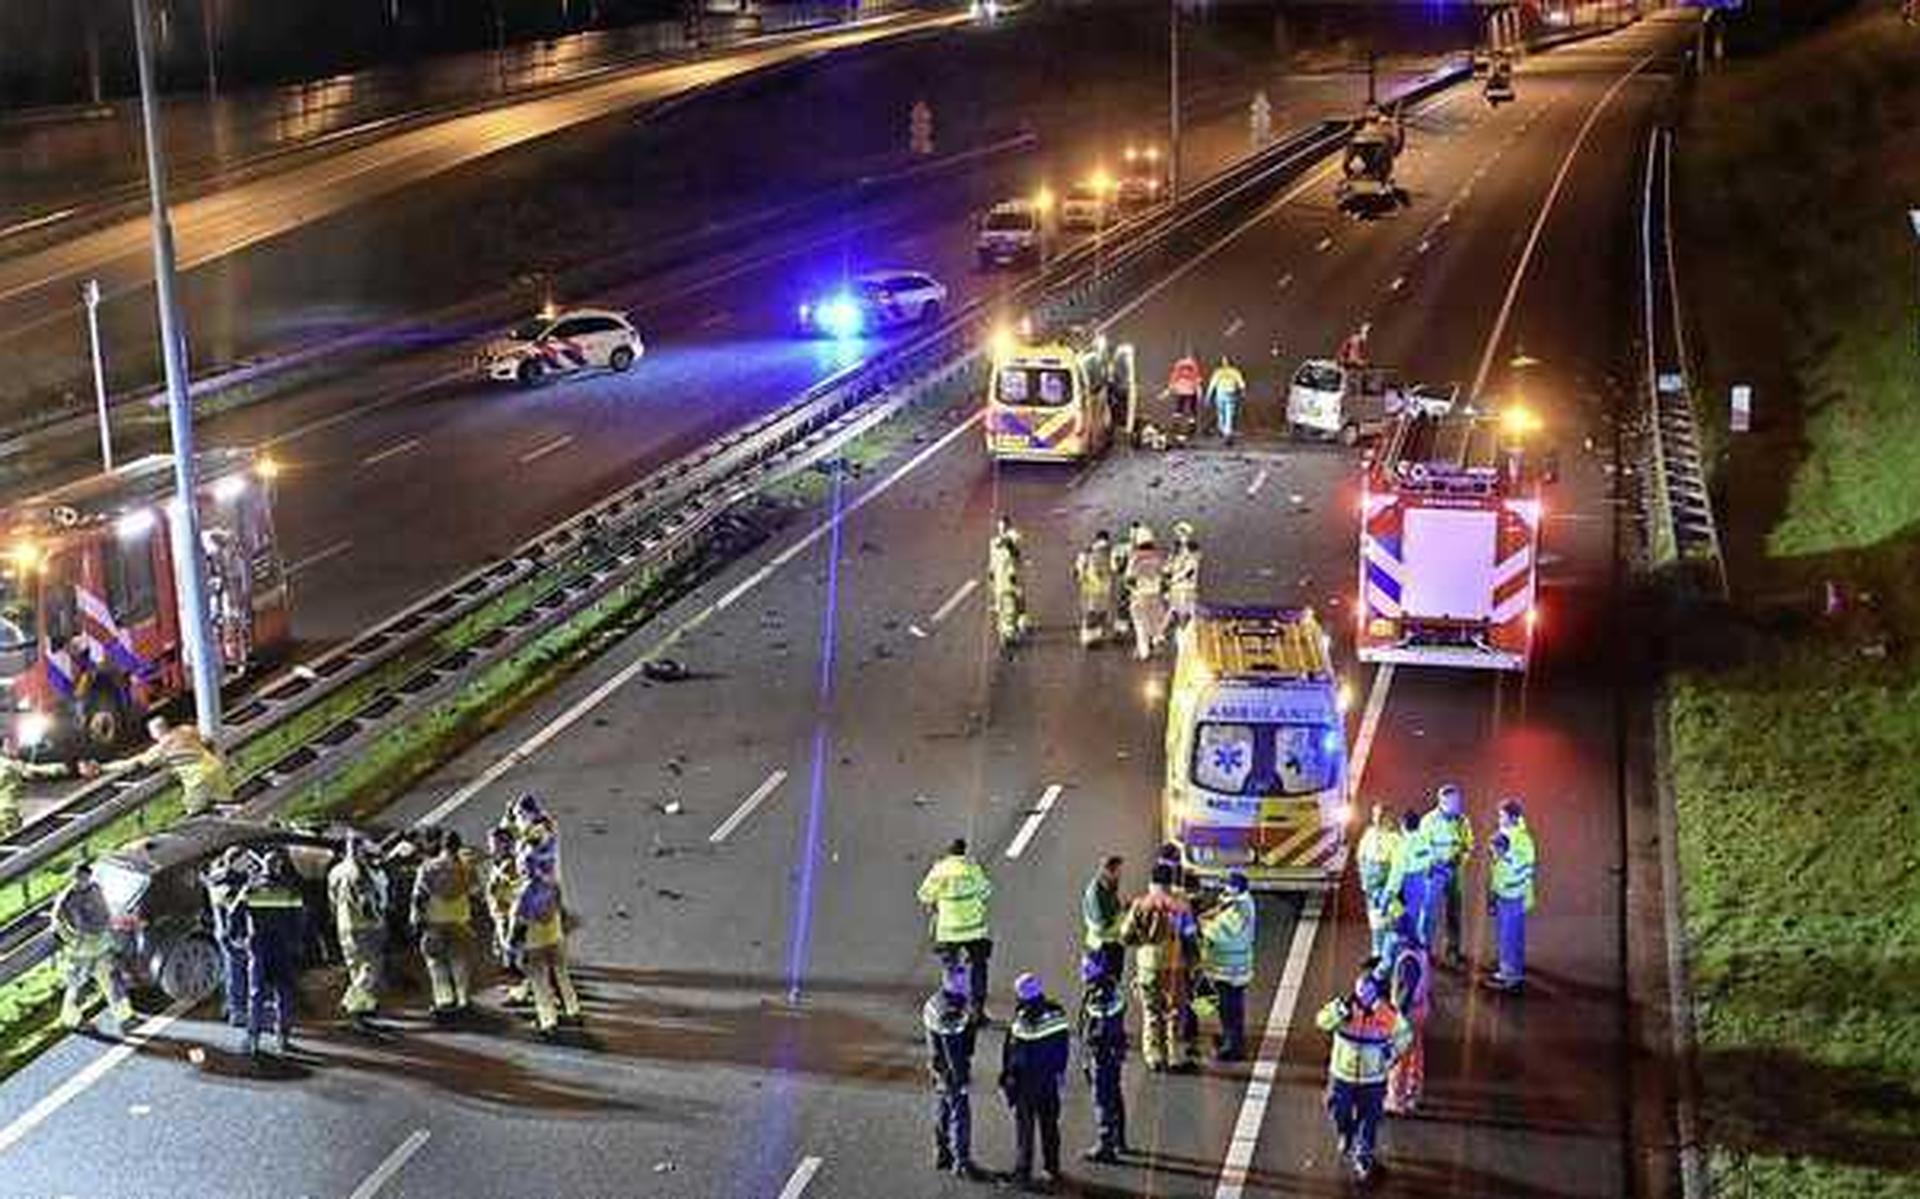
[0,450,292,757]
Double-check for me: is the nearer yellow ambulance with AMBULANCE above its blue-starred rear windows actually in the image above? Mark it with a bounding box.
[1162,603,1352,890]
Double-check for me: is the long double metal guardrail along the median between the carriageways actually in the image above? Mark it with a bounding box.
[0,58,1465,984]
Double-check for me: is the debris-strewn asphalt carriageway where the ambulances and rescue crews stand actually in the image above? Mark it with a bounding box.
[0,17,1686,1199]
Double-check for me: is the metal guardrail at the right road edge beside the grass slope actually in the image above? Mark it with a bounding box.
[1640,129,1726,598]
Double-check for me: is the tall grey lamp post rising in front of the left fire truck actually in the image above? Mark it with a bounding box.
[132,0,221,742]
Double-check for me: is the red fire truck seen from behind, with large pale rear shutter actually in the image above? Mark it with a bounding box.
[1354,409,1544,671]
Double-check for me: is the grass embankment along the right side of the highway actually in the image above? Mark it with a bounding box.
[1670,10,1920,1199]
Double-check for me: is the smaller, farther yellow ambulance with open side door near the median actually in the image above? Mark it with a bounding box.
[985,329,1139,461]
